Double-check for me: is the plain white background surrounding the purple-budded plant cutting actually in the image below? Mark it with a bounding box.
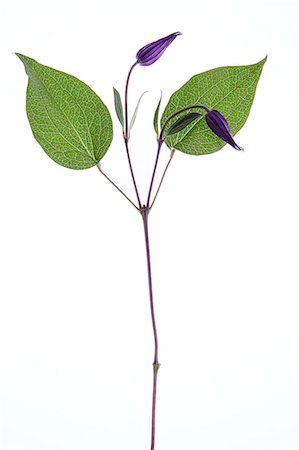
[0,0,299,450]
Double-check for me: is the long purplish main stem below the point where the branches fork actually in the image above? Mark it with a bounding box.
[141,206,160,450]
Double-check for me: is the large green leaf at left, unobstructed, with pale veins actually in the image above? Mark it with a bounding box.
[16,53,113,169]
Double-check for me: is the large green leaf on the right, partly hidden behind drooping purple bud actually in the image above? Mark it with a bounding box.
[161,58,267,155]
